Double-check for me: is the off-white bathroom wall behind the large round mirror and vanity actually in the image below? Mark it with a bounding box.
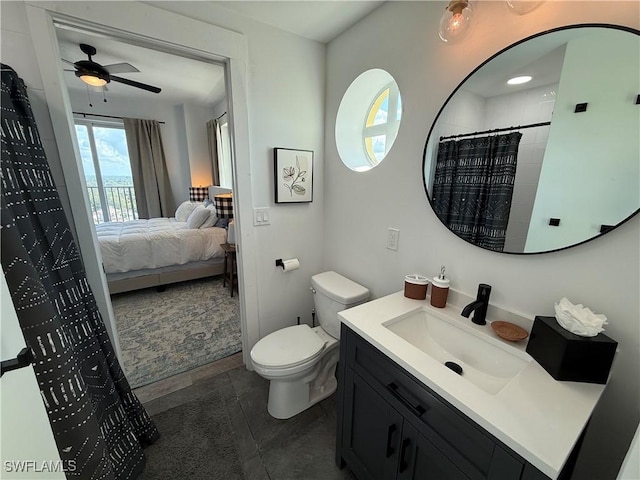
[323,1,640,478]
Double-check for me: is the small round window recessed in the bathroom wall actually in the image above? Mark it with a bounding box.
[336,69,402,172]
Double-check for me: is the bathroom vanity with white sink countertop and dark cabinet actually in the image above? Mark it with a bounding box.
[336,292,604,480]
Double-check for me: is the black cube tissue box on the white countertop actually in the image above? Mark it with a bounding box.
[527,317,618,384]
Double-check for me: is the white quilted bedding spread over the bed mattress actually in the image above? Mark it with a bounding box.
[96,218,227,273]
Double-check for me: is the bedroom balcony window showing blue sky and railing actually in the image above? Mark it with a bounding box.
[75,120,138,224]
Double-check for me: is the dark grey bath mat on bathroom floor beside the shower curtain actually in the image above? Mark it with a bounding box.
[138,391,244,480]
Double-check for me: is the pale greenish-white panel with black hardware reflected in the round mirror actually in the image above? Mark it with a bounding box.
[526,30,640,251]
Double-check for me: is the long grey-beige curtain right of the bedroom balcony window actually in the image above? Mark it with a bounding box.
[123,118,175,218]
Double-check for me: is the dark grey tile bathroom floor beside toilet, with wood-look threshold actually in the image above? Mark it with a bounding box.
[136,353,355,480]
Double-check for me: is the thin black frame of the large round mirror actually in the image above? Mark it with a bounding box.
[422,23,640,255]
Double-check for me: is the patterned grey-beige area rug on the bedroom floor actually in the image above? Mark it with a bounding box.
[111,277,242,388]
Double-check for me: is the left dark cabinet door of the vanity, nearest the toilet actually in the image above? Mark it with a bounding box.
[342,368,402,480]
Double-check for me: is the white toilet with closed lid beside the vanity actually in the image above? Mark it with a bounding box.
[251,272,369,419]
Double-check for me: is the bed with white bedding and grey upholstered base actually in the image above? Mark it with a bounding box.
[96,187,229,294]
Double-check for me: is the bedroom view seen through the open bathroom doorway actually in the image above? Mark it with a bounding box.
[56,25,242,387]
